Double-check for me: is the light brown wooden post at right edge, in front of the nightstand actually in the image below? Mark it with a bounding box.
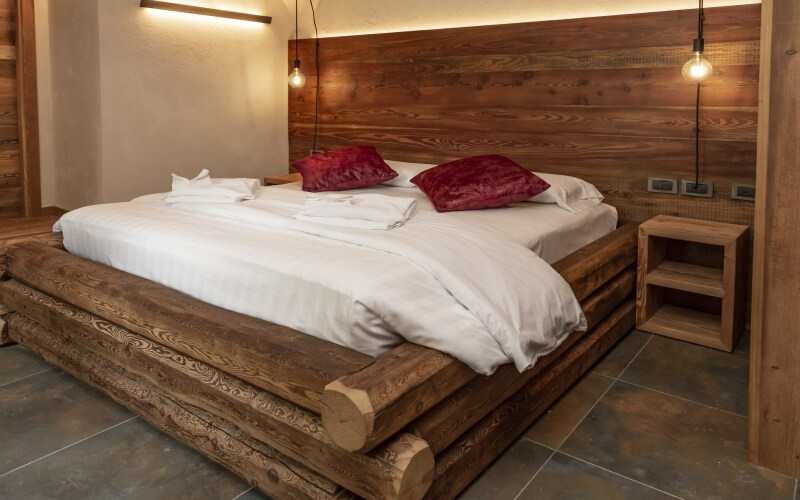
[748,0,800,477]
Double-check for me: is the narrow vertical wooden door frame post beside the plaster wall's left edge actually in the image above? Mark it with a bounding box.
[16,0,42,217]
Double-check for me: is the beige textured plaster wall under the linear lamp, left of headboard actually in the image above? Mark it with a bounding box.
[40,0,293,209]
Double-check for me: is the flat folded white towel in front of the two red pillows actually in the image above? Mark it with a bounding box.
[295,194,417,230]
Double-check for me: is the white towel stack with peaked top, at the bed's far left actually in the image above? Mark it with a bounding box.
[162,169,261,203]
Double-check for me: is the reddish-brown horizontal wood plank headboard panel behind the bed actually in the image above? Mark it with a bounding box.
[289,4,760,225]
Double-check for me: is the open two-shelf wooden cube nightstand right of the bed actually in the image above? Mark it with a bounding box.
[636,215,749,352]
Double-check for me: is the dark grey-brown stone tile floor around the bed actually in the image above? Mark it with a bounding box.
[0,330,800,500]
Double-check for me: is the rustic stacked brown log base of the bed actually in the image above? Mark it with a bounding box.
[0,226,637,499]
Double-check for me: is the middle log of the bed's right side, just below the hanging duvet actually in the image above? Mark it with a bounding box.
[406,266,635,455]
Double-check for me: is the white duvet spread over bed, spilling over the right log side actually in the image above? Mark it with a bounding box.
[56,186,616,374]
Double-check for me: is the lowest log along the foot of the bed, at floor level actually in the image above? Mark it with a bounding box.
[9,314,356,499]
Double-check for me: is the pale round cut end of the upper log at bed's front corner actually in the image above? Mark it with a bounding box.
[321,381,375,452]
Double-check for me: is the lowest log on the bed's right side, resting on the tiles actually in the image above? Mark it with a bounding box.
[426,299,635,499]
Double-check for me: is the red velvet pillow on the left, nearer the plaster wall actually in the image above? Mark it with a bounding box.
[292,146,397,191]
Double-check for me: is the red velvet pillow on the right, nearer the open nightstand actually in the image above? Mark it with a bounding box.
[411,155,550,212]
